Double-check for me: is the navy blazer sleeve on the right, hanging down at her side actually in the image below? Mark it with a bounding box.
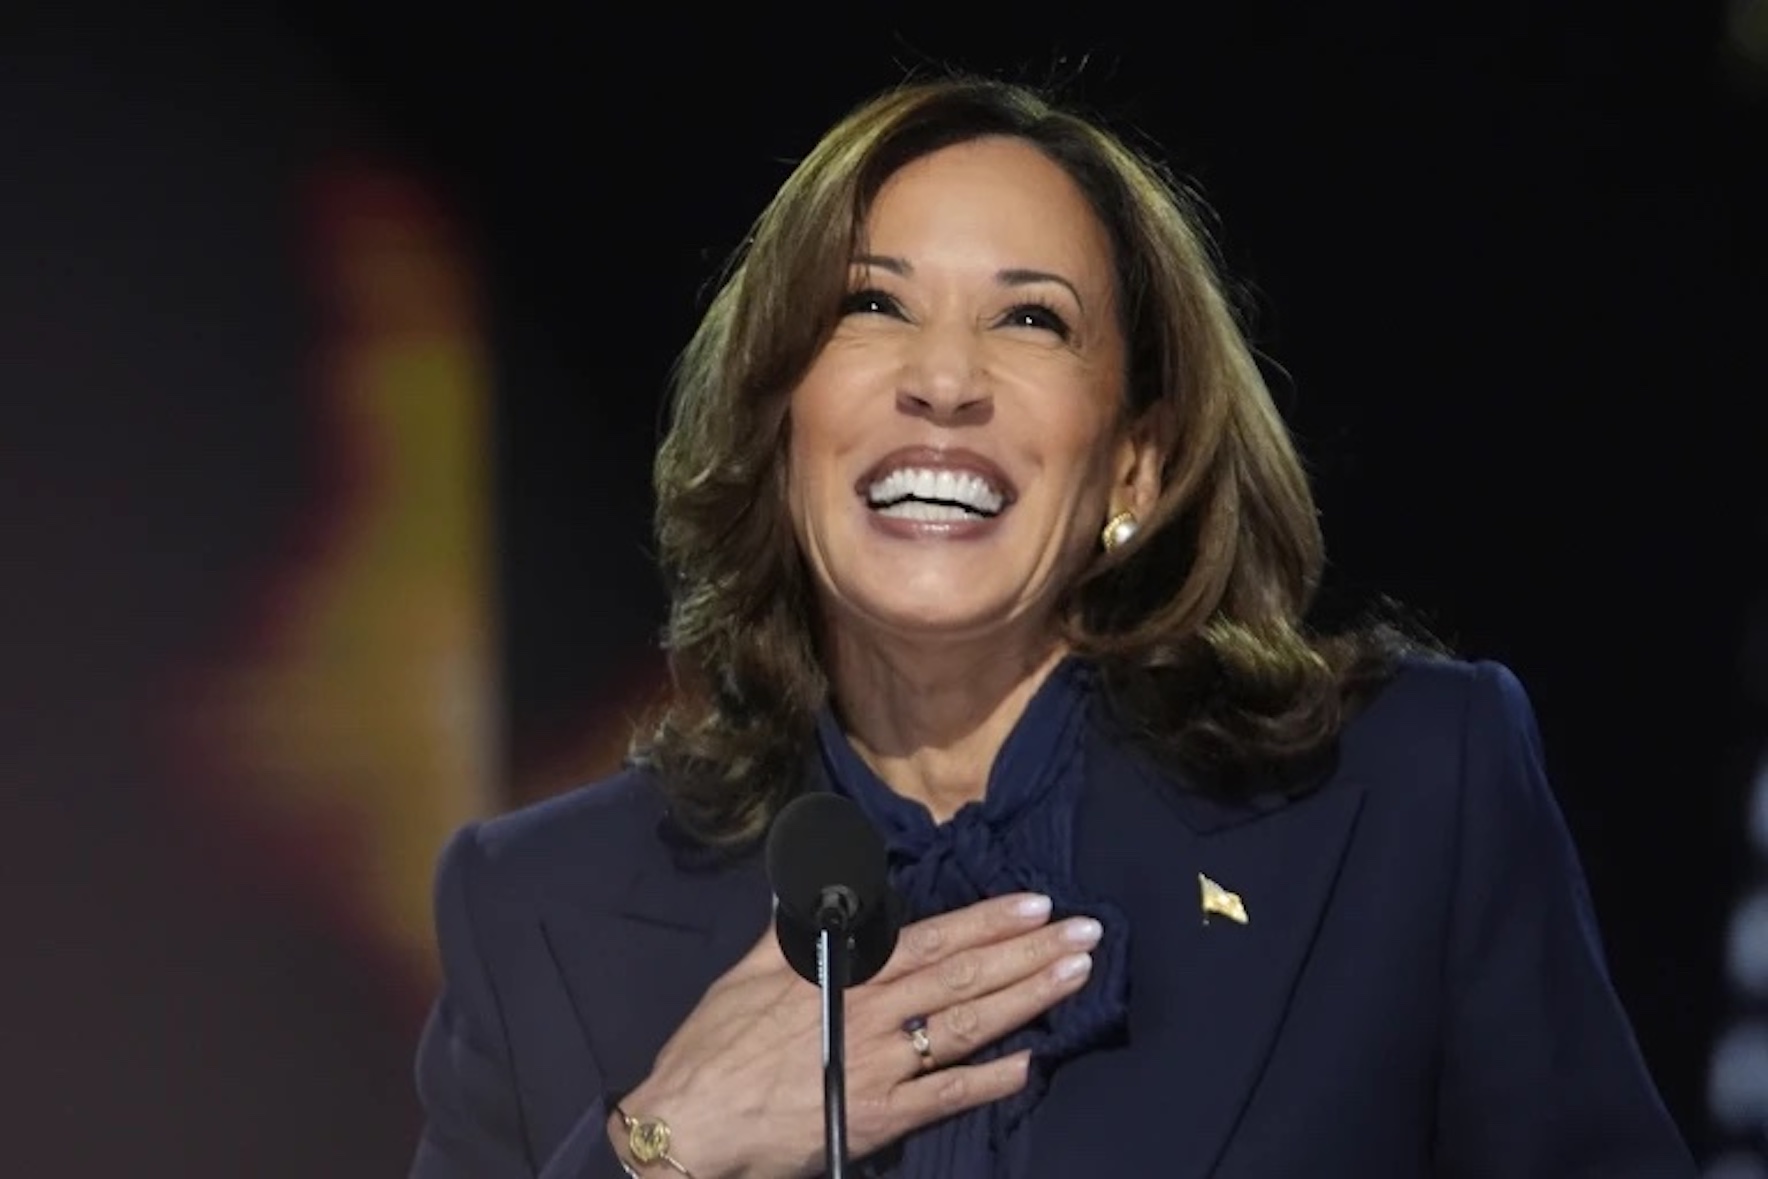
[1436,663,1696,1179]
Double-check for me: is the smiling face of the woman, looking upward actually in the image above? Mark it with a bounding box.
[789,138,1151,654]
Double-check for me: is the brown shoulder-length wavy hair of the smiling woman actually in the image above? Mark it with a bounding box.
[633,76,1407,845]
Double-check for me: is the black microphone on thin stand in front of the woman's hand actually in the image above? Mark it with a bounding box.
[767,792,900,1179]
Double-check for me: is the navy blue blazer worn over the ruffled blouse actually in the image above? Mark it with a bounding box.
[412,663,1694,1179]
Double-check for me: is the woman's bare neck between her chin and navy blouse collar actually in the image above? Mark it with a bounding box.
[829,633,1066,822]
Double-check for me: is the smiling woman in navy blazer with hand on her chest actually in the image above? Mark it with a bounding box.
[414,80,1694,1179]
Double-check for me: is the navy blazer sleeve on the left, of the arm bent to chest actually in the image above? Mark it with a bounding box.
[410,825,628,1179]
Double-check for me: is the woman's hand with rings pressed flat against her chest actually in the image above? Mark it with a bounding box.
[610,894,1100,1179]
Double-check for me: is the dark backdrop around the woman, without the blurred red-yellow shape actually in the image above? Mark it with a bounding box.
[0,0,1768,1175]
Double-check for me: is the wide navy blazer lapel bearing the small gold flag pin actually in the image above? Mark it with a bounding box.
[1033,753,1363,1177]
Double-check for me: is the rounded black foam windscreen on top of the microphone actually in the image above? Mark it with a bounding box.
[767,790,888,923]
